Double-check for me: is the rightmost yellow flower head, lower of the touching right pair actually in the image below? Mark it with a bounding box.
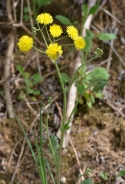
[74,36,86,50]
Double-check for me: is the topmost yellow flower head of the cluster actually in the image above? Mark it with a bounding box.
[36,13,53,25]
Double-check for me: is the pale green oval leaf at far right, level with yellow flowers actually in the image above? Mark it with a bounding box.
[96,33,116,41]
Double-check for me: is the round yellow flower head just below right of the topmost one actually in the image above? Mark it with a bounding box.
[49,24,63,37]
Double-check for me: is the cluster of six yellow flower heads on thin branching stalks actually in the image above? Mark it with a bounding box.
[18,13,86,61]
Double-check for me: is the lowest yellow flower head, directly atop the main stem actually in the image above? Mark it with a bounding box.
[46,43,63,60]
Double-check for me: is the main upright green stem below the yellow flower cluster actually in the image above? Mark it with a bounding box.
[53,61,67,184]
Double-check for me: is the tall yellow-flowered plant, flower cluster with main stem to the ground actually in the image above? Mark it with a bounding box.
[18,13,86,184]
